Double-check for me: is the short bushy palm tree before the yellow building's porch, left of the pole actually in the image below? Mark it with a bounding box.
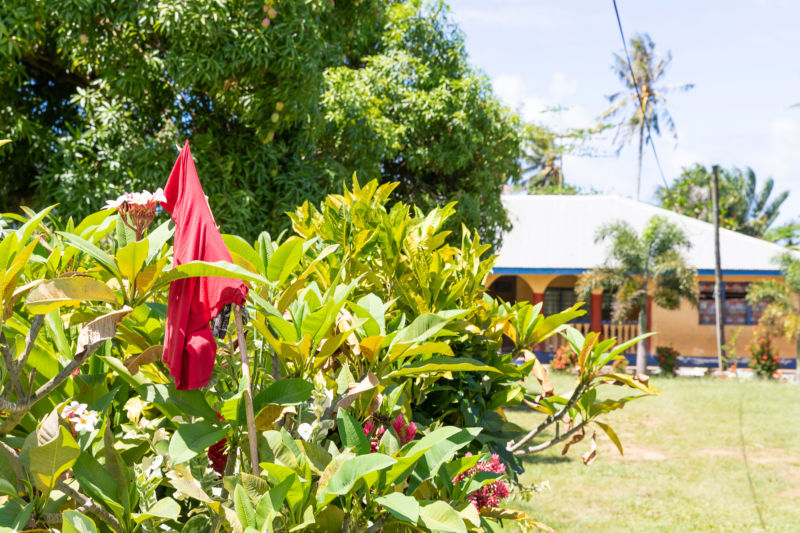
[575,217,697,374]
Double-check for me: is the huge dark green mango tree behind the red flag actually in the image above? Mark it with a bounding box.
[0,0,521,242]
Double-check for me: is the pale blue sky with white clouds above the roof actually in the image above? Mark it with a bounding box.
[449,0,800,222]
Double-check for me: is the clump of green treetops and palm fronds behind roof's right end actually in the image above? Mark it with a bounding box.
[656,164,789,238]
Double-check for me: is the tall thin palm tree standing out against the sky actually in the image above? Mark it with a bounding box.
[600,33,694,200]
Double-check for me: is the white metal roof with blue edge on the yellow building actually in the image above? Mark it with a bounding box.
[494,194,786,274]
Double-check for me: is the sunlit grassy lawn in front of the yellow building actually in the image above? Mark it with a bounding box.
[509,376,800,533]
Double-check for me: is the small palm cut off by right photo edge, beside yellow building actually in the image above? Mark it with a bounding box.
[747,252,800,384]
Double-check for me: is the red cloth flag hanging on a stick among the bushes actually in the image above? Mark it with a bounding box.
[161,141,247,390]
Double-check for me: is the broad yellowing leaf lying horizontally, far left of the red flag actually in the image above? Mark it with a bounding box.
[25,276,117,315]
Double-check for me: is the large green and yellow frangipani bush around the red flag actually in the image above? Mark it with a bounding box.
[0,181,654,533]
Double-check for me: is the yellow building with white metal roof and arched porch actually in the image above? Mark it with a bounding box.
[488,195,795,368]
